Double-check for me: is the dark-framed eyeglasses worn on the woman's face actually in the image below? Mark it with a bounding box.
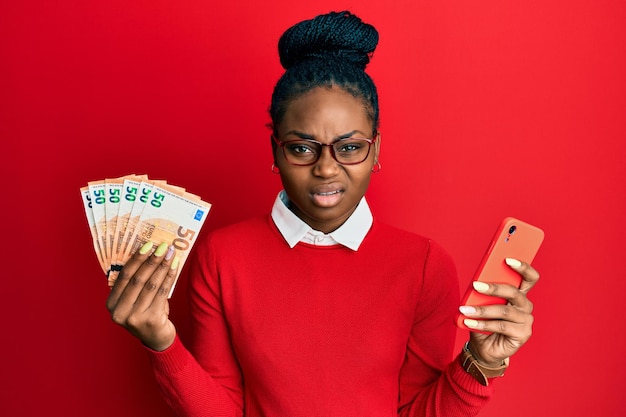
[272,133,378,166]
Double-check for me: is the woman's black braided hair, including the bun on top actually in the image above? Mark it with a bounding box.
[270,11,379,133]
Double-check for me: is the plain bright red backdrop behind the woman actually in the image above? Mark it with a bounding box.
[0,0,626,417]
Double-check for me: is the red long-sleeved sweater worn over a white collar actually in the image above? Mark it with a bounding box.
[150,215,492,417]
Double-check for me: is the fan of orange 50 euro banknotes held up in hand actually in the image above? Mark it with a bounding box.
[80,175,211,297]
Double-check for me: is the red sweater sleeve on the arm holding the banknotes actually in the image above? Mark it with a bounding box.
[148,234,243,417]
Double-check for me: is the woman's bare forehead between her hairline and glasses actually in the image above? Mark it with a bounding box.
[278,87,373,136]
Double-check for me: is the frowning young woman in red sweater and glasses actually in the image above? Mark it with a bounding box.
[107,12,539,417]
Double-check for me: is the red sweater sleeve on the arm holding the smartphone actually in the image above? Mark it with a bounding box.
[398,241,493,417]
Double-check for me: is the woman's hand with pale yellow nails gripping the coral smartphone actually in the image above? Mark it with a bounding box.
[460,258,539,367]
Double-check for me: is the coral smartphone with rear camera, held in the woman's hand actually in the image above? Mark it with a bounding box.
[456,217,544,331]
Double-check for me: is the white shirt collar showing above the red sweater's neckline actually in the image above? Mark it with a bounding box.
[272,190,373,251]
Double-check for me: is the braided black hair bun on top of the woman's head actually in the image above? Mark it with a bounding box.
[278,11,378,69]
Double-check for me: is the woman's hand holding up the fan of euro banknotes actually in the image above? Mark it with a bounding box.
[106,242,179,351]
